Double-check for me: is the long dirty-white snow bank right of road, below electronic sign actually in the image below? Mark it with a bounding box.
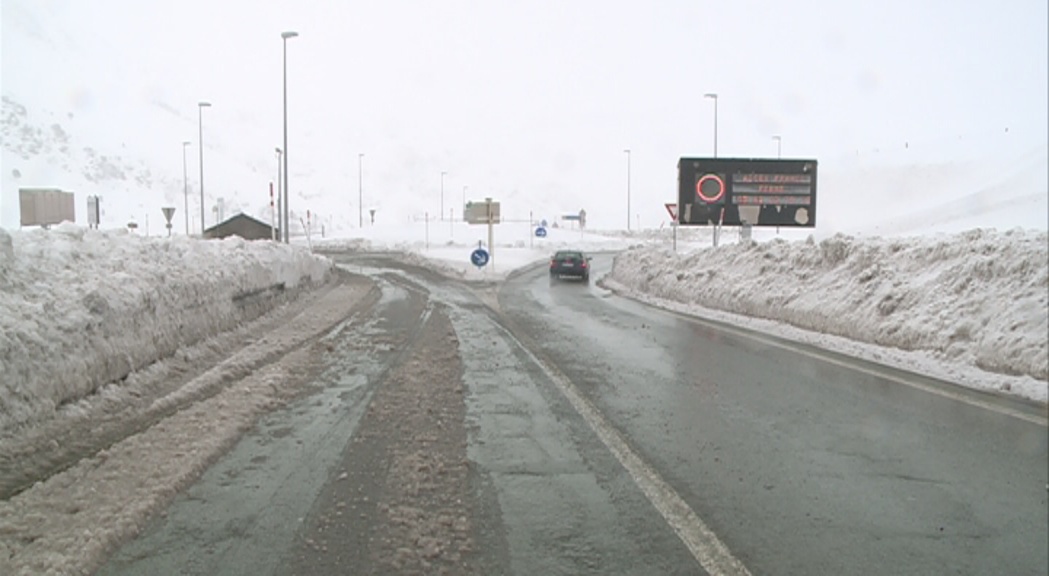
[611,230,1049,381]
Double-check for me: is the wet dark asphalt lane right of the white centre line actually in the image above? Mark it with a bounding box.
[500,255,1049,575]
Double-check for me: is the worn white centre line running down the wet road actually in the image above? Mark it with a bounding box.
[494,322,750,576]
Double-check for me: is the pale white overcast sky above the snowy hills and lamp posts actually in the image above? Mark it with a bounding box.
[2,0,1049,226]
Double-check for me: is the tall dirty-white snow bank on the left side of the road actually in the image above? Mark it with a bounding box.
[0,225,333,432]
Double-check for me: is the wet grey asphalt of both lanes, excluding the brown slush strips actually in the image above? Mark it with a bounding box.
[94,256,1049,574]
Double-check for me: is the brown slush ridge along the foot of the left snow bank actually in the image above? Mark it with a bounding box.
[0,278,373,576]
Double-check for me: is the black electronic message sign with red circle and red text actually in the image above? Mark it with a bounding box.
[678,158,816,228]
